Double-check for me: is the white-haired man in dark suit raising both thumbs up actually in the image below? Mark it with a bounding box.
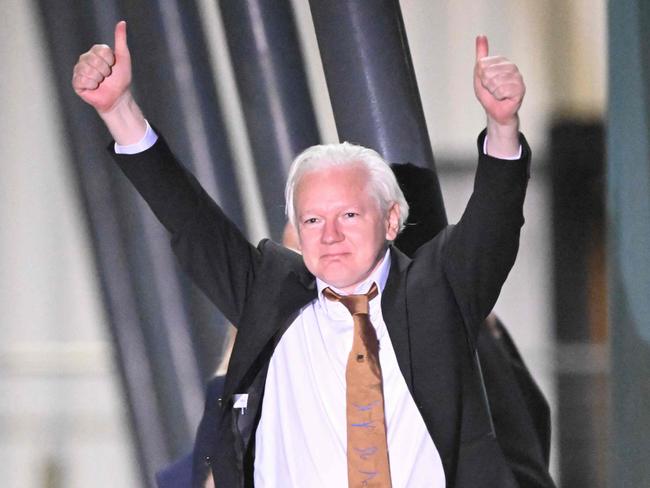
[73,22,530,487]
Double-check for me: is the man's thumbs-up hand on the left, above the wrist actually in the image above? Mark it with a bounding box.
[72,21,131,115]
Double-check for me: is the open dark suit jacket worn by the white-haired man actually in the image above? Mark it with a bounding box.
[115,127,530,488]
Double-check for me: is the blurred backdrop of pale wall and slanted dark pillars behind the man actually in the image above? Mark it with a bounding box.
[0,0,650,488]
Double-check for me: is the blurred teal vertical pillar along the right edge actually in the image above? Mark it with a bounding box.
[607,0,650,486]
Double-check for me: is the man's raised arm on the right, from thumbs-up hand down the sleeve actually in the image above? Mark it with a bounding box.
[443,36,530,341]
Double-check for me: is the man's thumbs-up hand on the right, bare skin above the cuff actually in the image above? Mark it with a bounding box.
[474,36,526,127]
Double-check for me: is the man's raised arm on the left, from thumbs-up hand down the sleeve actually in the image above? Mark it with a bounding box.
[72,21,261,324]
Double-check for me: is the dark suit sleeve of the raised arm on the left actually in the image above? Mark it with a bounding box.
[109,133,261,324]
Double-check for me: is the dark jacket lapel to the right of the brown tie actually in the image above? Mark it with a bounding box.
[381,246,413,395]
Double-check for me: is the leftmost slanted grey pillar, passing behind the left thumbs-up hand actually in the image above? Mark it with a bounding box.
[33,0,170,486]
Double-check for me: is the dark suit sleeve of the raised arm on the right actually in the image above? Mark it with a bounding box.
[442,131,531,345]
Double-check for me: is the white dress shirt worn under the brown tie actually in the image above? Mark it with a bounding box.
[255,251,445,488]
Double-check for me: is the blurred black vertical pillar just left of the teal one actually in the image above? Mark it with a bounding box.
[550,117,608,488]
